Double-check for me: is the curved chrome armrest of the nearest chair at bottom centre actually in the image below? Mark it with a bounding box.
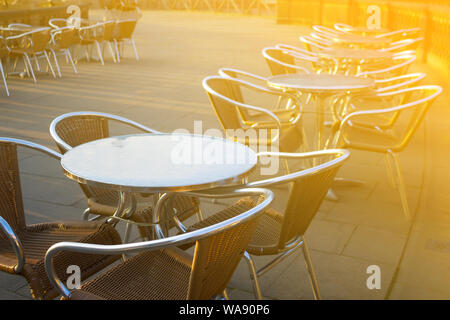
[45,188,274,297]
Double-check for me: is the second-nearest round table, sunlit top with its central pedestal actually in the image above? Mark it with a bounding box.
[267,73,374,150]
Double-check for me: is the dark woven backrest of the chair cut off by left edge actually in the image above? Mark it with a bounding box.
[0,142,25,234]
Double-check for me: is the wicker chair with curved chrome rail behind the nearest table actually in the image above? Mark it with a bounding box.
[50,112,201,239]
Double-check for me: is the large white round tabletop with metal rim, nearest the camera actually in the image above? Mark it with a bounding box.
[61,133,257,193]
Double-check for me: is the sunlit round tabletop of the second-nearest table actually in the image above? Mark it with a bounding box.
[267,73,374,92]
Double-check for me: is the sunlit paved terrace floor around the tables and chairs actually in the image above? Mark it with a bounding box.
[0,11,450,299]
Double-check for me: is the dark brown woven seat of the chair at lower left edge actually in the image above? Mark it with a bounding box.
[0,221,121,299]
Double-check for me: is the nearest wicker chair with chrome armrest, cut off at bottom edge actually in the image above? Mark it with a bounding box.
[46,188,273,300]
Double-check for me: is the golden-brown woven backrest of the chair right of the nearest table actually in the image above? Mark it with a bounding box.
[279,158,340,248]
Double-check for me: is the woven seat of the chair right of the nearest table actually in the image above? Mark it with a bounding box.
[182,199,283,255]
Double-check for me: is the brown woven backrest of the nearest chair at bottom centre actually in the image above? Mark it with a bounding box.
[187,206,259,300]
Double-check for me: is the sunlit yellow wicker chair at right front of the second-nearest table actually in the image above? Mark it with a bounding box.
[333,86,442,219]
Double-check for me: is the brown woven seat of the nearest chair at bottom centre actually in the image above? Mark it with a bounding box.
[70,248,192,300]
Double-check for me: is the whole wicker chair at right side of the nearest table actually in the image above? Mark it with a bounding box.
[178,150,350,299]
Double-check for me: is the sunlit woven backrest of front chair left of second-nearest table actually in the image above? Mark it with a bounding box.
[206,78,242,130]
